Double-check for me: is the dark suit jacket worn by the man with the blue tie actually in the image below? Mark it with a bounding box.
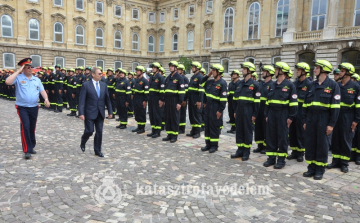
[79,81,112,120]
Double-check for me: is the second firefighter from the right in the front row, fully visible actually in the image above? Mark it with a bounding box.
[264,62,298,169]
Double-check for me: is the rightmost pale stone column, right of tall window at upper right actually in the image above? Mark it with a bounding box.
[323,0,339,39]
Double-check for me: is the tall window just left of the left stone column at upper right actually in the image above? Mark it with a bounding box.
[275,0,289,37]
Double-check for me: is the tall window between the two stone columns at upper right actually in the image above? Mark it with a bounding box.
[311,0,328,31]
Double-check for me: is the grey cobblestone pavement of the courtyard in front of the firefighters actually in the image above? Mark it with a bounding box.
[0,100,360,222]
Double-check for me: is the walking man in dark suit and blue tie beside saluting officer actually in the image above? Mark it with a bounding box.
[79,67,112,157]
